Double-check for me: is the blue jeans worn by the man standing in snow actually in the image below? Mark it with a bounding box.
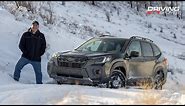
[14,57,42,84]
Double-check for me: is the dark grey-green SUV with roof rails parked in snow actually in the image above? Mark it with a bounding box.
[47,35,168,89]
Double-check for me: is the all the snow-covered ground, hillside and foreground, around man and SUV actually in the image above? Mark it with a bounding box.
[0,2,185,104]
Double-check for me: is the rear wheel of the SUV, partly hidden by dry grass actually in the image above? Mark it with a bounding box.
[153,71,164,90]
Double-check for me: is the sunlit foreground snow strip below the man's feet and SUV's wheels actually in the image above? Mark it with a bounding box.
[0,74,185,105]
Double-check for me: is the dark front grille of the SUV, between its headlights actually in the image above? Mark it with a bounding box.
[58,57,86,68]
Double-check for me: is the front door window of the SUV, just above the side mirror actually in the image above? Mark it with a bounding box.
[128,41,141,56]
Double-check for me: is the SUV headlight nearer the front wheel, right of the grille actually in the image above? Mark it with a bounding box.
[92,56,112,63]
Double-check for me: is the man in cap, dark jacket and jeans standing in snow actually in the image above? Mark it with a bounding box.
[14,21,46,84]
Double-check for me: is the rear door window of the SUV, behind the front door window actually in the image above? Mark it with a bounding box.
[141,42,153,56]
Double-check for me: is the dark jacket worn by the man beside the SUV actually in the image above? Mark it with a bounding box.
[19,29,46,62]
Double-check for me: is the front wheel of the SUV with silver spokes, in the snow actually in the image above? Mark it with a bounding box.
[109,70,125,89]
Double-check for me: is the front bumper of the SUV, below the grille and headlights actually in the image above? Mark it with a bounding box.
[47,60,108,85]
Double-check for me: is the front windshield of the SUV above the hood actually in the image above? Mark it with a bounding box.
[75,38,125,52]
